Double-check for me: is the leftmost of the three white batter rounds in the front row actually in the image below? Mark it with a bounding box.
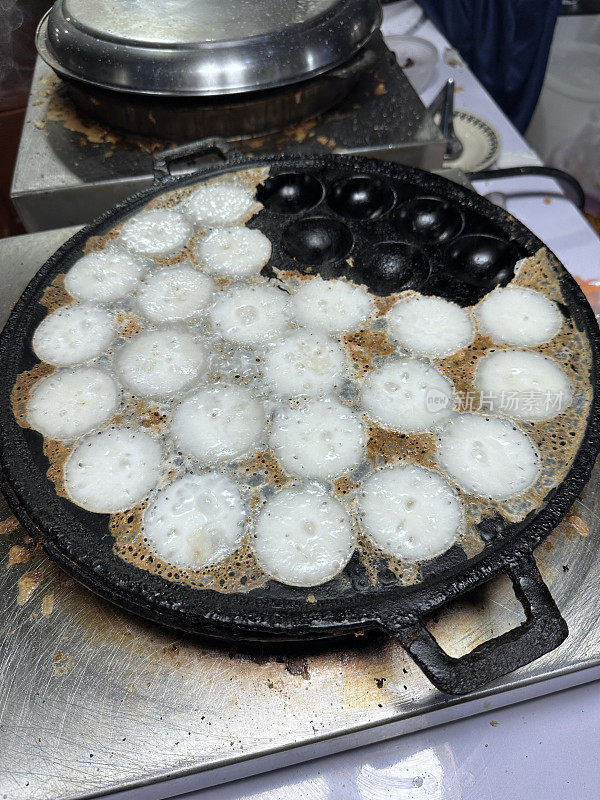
[143,472,246,569]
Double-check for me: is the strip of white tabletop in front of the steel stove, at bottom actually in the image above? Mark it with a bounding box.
[185,683,600,800]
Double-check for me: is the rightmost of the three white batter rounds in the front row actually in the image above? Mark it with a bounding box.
[358,462,463,561]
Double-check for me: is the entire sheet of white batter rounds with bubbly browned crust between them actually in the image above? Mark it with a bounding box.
[13,168,589,591]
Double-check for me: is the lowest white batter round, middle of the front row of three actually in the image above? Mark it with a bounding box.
[250,487,356,586]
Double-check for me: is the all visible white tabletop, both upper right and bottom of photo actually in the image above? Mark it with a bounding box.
[177,0,600,800]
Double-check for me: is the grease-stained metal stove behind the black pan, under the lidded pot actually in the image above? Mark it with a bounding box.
[11,40,444,231]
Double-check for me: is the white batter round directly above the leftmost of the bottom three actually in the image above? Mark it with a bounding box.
[171,384,265,464]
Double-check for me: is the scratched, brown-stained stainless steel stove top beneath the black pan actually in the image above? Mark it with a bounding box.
[0,223,600,800]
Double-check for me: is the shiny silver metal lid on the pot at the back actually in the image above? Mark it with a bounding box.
[36,0,381,96]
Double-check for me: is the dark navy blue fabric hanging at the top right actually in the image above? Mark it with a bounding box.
[418,0,561,131]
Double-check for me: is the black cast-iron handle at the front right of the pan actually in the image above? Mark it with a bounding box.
[380,555,569,695]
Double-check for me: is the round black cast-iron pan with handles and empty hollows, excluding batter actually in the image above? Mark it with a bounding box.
[0,140,600,694]
